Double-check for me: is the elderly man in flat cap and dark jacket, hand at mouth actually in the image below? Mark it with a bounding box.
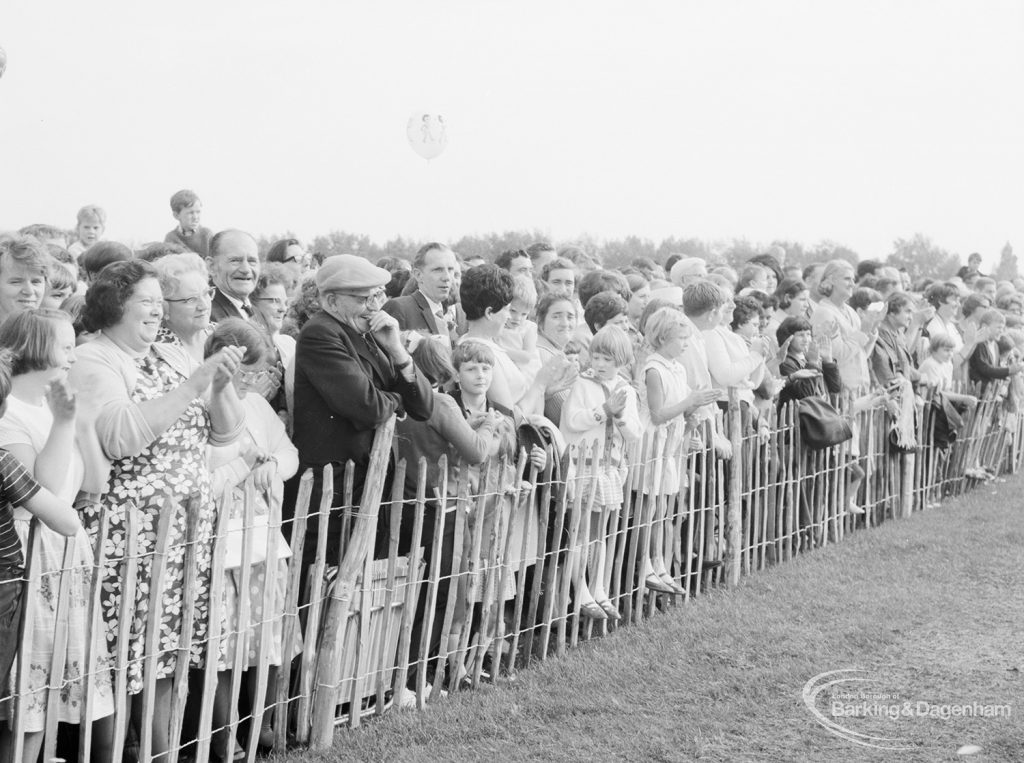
[294,254,433,578]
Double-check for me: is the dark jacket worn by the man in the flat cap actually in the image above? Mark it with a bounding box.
[294,312,433,471]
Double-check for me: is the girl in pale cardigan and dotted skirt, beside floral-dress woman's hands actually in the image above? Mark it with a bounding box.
[206,319,299,747]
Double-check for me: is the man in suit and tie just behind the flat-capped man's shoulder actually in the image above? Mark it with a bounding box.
[384,243,460,344]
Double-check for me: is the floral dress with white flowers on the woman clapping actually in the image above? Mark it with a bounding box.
[83,350,216,694]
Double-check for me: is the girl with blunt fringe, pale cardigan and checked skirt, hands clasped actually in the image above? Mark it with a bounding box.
[560,326,642,620]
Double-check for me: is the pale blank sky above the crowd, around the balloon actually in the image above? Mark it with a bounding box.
[0,0,1024,264]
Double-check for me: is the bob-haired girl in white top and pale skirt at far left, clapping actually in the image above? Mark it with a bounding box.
[0,310,99,761]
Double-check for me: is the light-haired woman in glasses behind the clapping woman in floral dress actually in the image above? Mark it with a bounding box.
[154,252,213,363]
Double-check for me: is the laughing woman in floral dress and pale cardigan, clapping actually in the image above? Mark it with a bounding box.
[69,260,245,759]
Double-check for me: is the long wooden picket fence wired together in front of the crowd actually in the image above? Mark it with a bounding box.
[8,386,1024,761]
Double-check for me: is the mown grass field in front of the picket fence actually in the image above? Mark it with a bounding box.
[278,477,1024,763]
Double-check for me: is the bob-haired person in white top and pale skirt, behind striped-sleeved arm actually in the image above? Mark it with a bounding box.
[0,309,114,761]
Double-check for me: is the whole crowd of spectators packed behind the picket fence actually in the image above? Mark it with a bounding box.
[0,190,1024,761]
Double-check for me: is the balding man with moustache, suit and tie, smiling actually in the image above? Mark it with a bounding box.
[206,229,260,323]
